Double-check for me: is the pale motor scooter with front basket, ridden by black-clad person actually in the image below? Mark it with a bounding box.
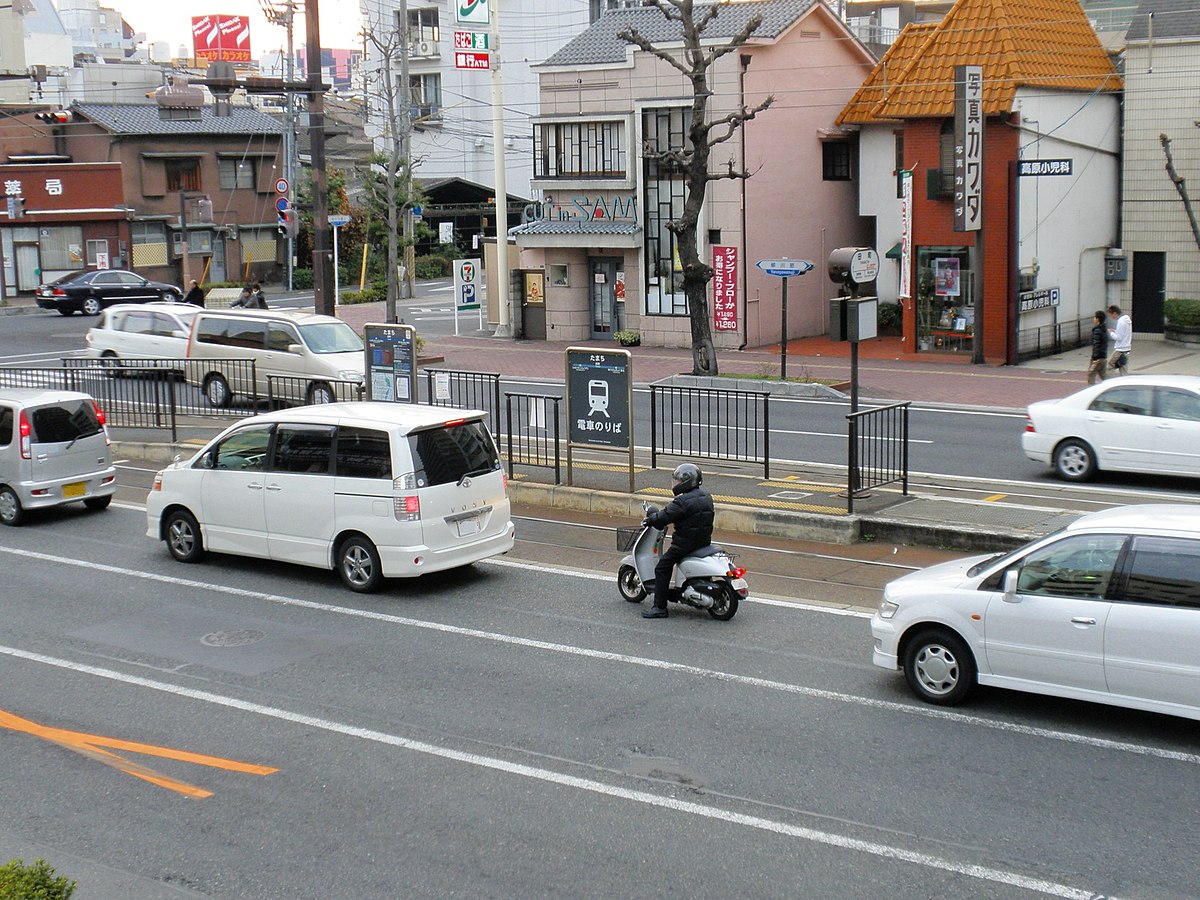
[617,503,750,622]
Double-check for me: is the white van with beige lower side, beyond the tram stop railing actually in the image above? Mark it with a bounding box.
[185,310,365,408]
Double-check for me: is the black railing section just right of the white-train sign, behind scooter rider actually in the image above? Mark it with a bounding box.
[650,384,770,478]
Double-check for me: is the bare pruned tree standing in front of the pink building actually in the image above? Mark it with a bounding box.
[617,0,772,376]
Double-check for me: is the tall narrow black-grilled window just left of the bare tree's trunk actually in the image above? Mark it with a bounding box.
[642,108,688,316]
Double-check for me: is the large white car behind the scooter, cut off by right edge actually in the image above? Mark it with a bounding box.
[871,504,1200,719]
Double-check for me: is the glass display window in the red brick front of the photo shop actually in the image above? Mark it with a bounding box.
[917,247,976,353]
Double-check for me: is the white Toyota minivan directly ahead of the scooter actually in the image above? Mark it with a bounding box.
[146,401,515,592]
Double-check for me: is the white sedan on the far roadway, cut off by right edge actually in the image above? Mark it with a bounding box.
[1021,376,1200,481]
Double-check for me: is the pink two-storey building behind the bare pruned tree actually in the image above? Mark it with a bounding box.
[514,0,874,349]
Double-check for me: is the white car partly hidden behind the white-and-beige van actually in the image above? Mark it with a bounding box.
[84,304,204,370]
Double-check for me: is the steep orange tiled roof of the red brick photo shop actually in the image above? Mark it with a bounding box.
[842,0,1122,121]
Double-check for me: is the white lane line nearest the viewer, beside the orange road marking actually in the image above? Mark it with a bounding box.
[0,646,1097,900]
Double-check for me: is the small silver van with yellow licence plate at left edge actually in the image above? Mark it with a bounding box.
[0,388,116,526]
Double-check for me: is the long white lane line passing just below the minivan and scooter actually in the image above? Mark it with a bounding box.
[0,547,1200,766]
